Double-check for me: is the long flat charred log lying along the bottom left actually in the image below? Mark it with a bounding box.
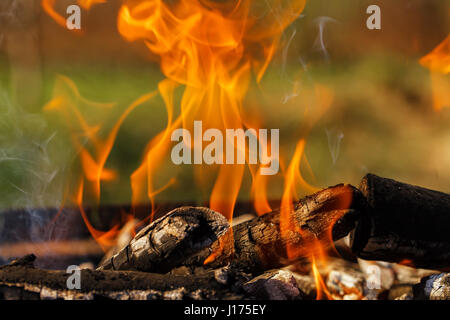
[0,255,242,300]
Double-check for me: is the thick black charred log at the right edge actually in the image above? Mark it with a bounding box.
[351,174,450,269]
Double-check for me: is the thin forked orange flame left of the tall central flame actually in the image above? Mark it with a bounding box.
[44,76,156,250]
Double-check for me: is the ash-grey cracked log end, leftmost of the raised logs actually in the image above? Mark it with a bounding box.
[98,207,229,273]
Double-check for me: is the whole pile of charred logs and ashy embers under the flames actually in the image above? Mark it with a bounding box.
[0,174,450,299]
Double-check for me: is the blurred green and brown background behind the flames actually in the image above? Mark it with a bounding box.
[0,0,450,212]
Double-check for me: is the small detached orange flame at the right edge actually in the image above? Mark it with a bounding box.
[420,35,450,111]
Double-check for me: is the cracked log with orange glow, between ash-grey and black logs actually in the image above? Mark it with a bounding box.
[185,184,366,272]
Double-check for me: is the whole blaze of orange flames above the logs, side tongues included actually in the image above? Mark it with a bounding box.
[42,0,352,282]
